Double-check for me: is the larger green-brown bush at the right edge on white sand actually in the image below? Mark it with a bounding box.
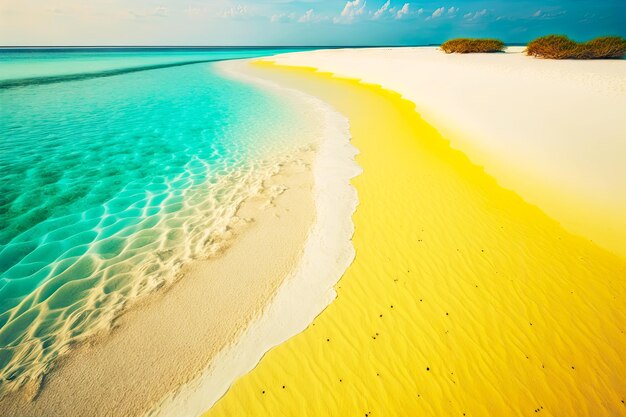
[526,35,626,59]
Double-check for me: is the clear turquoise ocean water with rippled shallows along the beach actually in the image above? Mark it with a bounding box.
[0,49,311,395]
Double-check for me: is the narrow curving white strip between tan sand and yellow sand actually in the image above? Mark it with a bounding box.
[146,63,361,417]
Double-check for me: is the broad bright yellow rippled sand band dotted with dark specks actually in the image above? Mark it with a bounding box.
[205,65,626,417]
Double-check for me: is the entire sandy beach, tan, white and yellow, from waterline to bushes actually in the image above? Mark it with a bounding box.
[0,48,626,417]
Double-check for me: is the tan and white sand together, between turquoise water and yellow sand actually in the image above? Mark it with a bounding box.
[0,61,358,417]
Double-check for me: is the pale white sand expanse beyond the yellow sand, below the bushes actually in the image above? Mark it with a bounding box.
[268,47,626,256]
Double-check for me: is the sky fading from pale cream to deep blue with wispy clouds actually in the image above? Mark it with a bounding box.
[0,0,626,46]
